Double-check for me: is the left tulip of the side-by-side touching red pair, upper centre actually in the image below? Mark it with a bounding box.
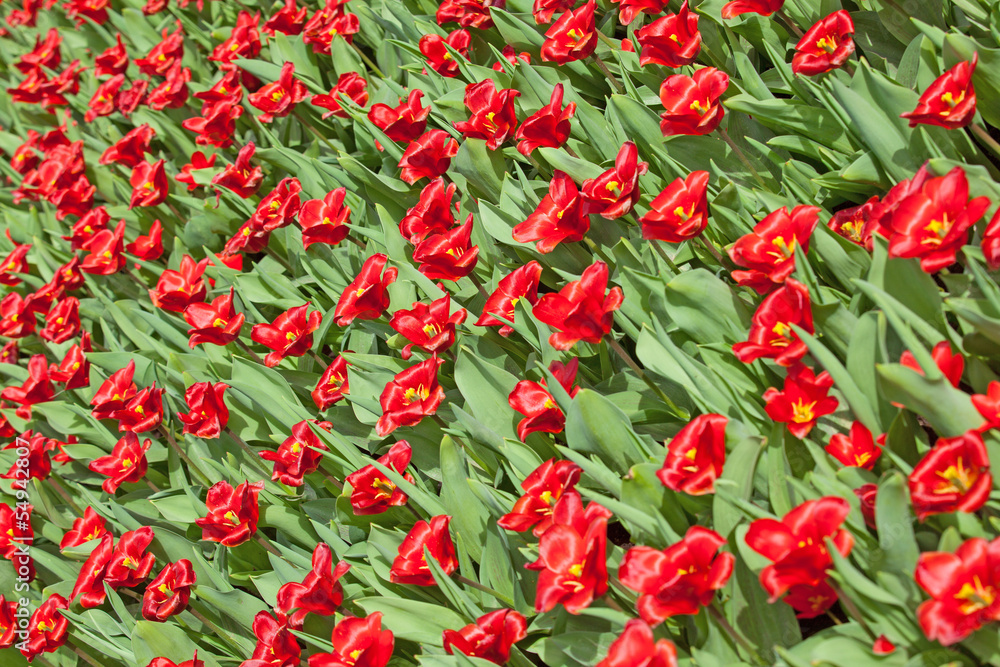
[513,169,590,253]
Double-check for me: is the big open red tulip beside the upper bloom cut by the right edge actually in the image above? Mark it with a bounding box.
[888,167,990,273]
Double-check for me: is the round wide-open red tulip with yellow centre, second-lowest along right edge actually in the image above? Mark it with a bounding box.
[909,431,993,521]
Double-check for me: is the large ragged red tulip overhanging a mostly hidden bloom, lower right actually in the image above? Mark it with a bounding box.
[746,496,854,613]
